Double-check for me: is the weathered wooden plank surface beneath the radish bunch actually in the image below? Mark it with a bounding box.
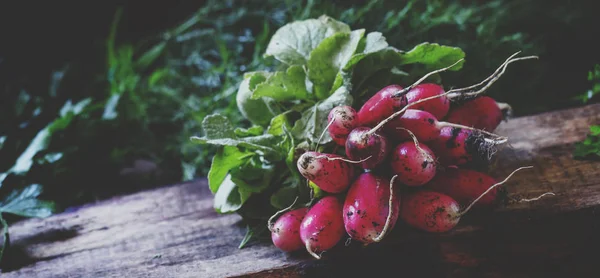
[0,105,600,278]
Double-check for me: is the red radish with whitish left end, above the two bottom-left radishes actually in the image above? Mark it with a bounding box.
[296,152,356,193]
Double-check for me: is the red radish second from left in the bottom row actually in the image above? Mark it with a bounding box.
[300,195,346,259]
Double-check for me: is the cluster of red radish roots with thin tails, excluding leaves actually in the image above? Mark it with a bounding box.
[269,53,531,258]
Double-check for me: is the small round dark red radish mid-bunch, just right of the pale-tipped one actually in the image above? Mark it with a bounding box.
[346,127,391,169]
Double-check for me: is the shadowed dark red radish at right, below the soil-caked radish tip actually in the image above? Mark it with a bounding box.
[427,168,498,206]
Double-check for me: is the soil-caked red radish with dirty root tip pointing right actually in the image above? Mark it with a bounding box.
[428,126,506,166]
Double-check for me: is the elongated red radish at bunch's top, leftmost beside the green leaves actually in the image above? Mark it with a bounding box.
[358,85,407,127]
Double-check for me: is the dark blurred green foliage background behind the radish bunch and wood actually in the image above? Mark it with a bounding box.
[0,0,600,212]
